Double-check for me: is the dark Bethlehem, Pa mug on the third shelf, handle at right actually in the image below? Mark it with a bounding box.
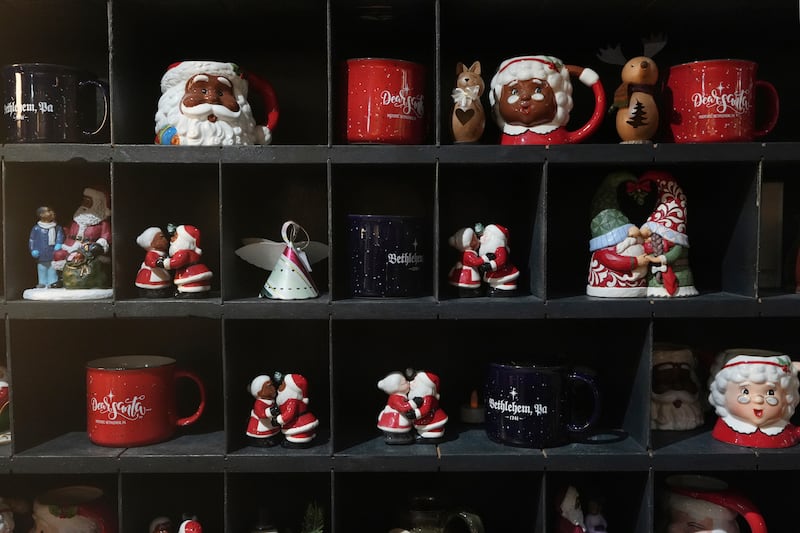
[485,363,600,448]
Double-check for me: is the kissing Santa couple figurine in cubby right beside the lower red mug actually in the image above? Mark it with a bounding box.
[246,372,319,448]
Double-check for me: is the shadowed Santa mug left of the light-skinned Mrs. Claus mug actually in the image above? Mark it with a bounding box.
[650,343,704,431]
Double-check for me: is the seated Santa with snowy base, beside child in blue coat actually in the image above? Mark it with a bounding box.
[22,187,113,300]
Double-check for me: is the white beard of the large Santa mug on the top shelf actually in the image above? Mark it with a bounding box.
[156,85,272,146]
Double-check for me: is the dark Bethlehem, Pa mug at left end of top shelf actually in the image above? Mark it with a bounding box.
[2,63,109,143]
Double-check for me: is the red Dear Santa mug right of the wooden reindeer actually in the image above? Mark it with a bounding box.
[666,59,779,143]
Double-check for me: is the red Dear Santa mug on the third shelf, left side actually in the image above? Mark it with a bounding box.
[86,355,206,448]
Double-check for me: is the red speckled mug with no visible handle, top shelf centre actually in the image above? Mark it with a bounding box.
[343,58,427,144]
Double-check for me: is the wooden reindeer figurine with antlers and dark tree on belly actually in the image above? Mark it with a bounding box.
[597,36,667,144]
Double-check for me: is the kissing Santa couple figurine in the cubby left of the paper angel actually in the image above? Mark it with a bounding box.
[135,224,214,298]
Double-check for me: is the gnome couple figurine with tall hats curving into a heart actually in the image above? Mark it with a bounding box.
[586,170,698,298]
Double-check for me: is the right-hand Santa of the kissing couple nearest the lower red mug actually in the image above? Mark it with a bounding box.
[270,374,319,448]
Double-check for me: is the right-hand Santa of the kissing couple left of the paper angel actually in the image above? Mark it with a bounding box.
[155,224,214,298]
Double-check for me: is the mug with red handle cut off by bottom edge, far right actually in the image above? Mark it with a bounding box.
[661,474,767,533]
